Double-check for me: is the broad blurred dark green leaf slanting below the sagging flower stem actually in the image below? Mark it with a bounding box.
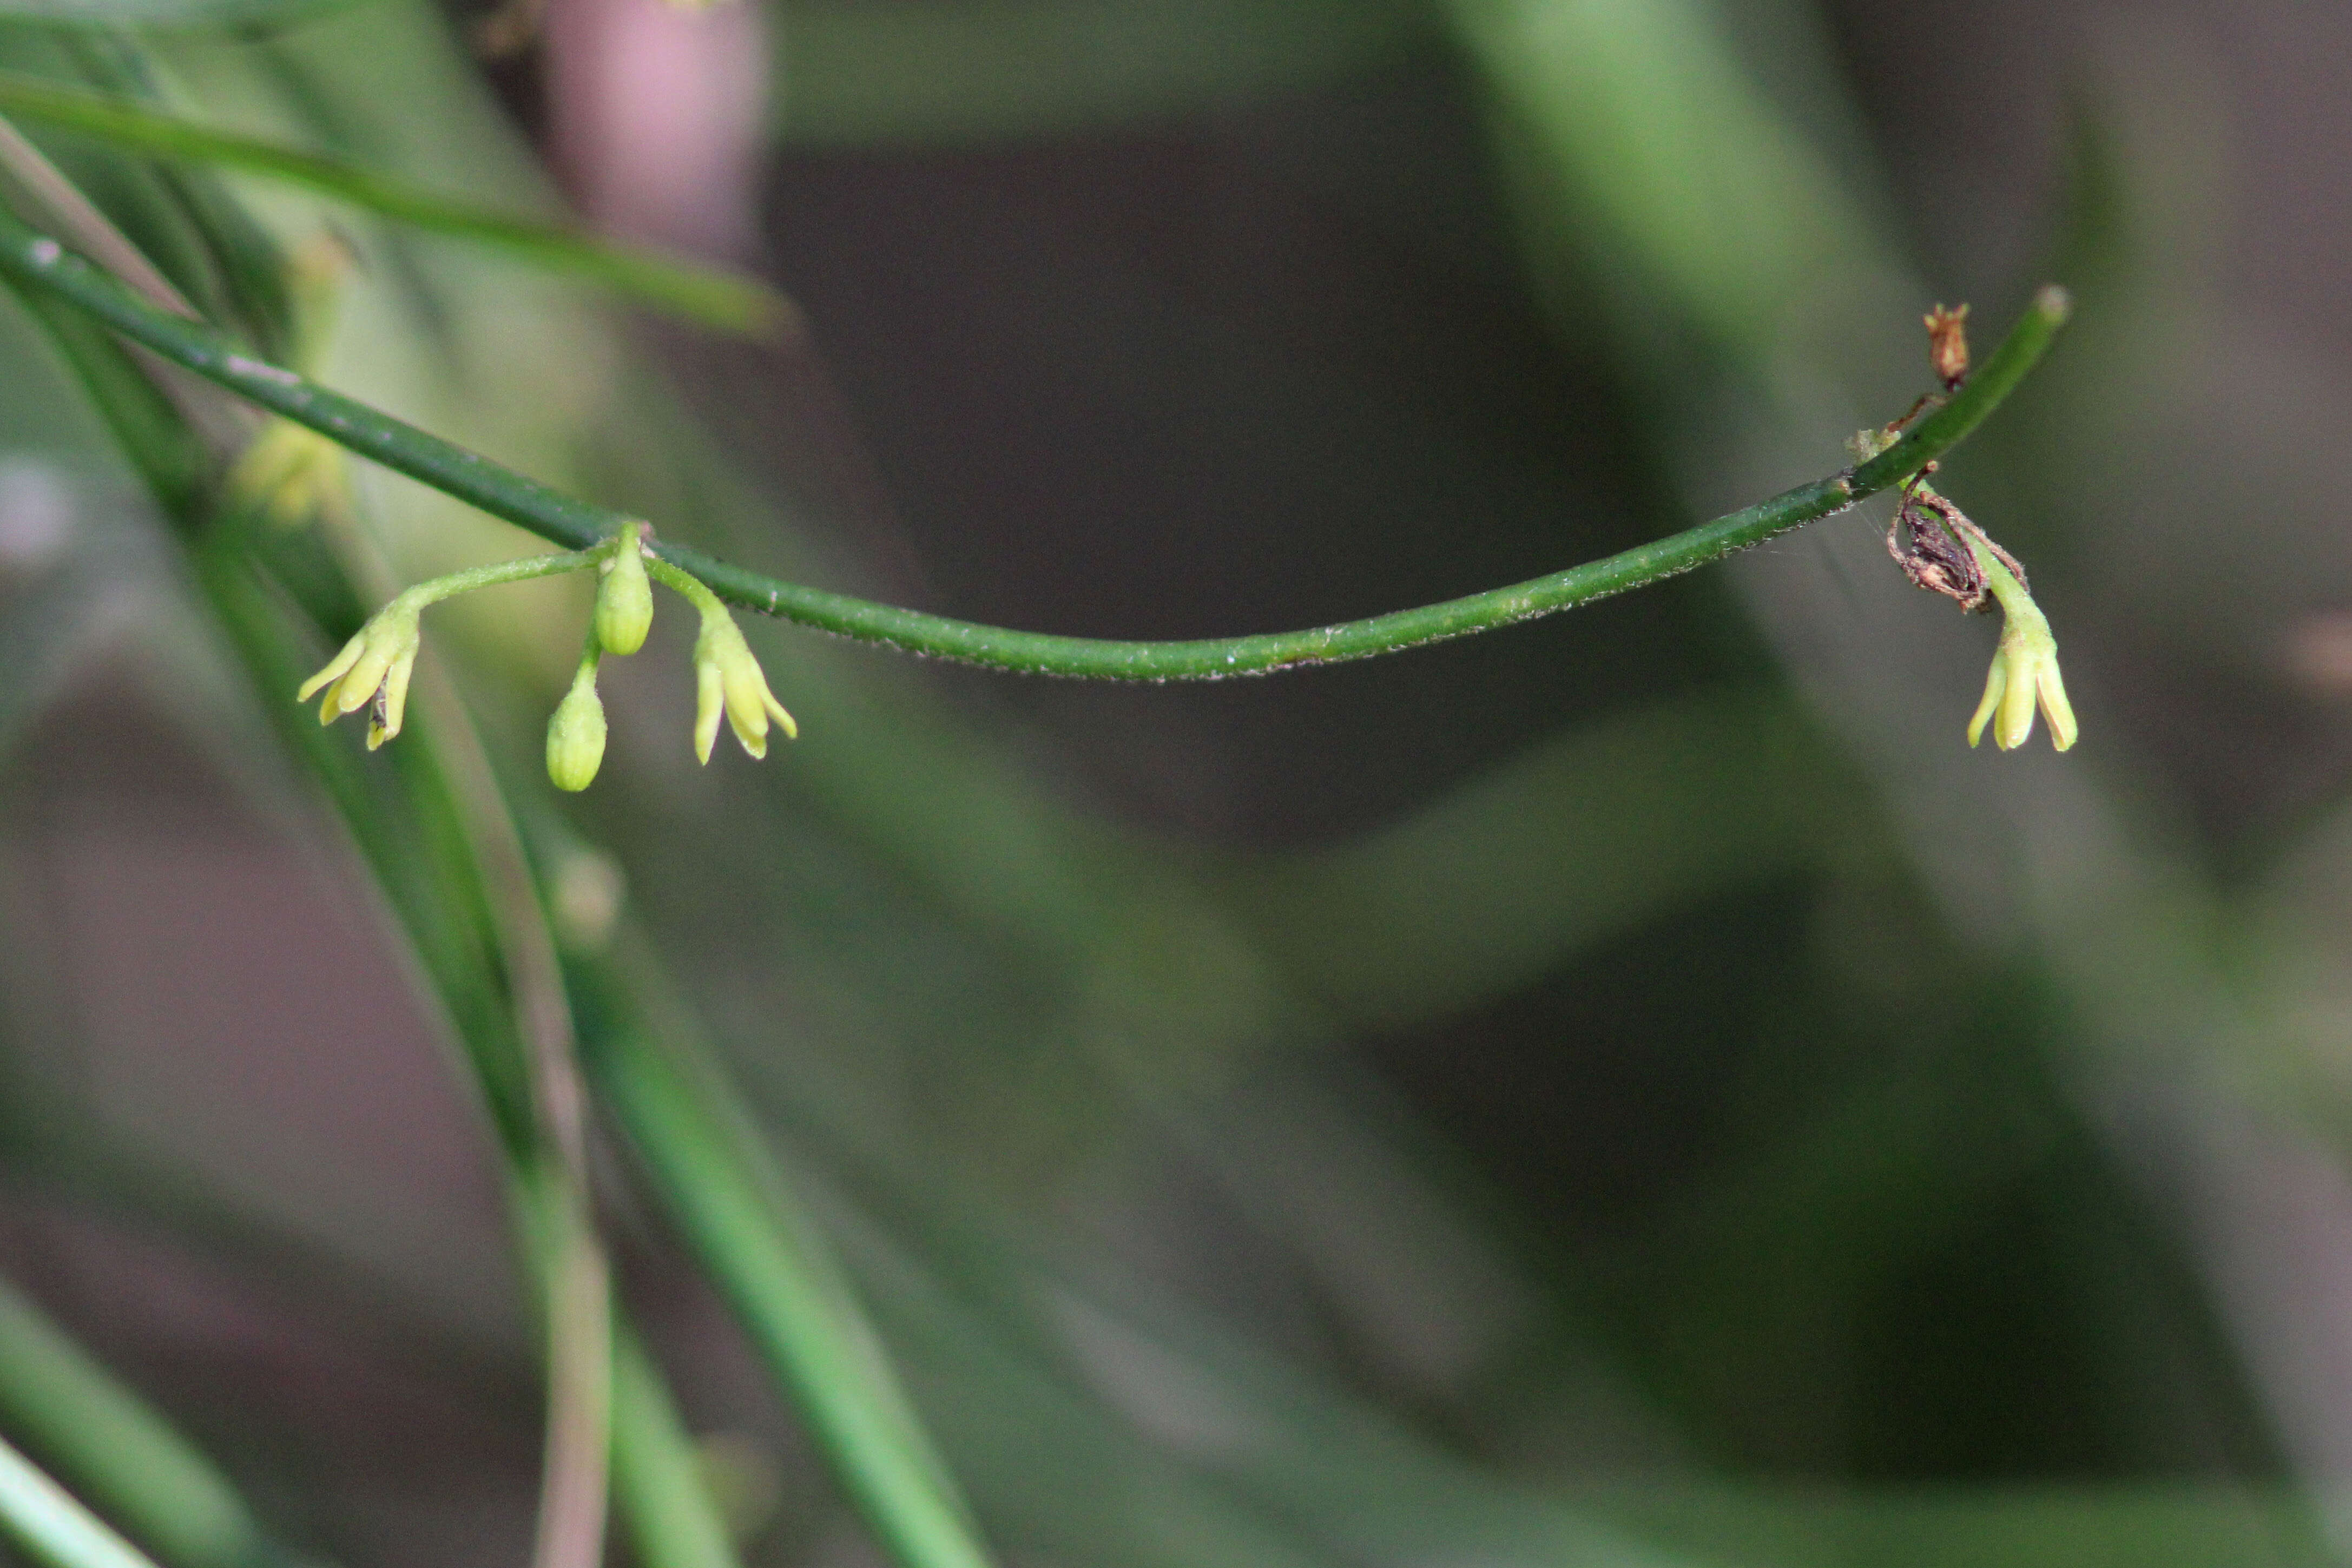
[1221,687,1868,1030]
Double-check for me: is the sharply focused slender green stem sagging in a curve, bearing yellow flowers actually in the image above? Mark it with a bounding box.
[0,200,2072,682]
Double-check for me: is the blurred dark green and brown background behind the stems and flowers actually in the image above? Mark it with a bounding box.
[0,0,2352,1563]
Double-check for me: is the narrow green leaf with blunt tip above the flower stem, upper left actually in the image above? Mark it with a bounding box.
[0,71,800,339]
